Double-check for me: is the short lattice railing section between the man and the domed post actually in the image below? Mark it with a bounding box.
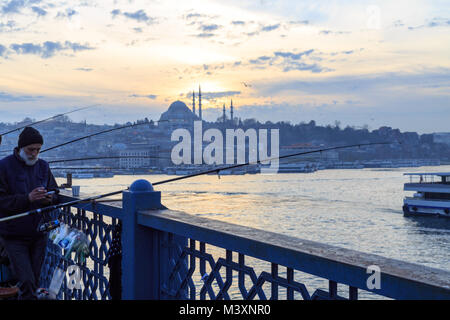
[41,196,122,300]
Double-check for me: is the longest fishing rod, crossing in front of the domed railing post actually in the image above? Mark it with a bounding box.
[0,142,393,222]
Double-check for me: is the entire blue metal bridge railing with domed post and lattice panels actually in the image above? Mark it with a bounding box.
[43,180,450,300]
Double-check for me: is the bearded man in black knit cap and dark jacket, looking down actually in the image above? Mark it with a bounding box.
[0,127,58,300]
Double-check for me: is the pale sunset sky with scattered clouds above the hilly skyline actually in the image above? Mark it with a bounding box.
[0,0,450,133]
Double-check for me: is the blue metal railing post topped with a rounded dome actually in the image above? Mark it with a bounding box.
[122,180,164,300]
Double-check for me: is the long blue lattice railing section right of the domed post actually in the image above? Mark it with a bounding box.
[137,210,450,300]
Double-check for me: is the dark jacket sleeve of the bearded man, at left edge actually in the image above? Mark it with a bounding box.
[0,169,30,216]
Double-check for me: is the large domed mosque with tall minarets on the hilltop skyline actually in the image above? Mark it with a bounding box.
[159,86,233,130]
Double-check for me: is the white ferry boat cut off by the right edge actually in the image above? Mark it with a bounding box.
[403,172,450,218]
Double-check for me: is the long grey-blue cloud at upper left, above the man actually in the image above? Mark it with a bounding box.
[10,41,94,59]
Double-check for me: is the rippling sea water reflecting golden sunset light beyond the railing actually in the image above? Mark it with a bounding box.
[58,166,450,299]
